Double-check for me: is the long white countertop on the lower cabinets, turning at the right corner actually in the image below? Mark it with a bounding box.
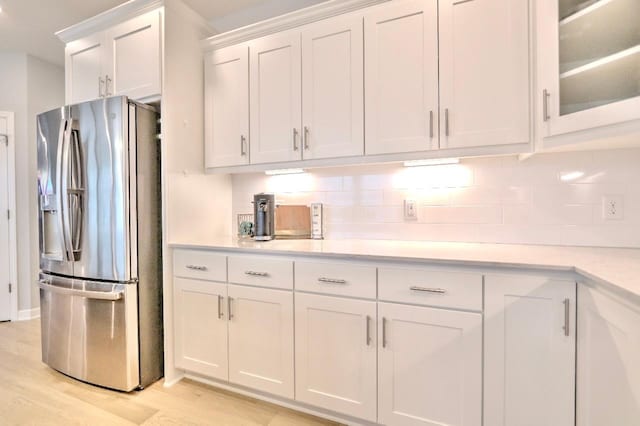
[169,237,640,297]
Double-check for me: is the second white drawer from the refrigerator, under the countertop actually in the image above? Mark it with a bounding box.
[229,256,293,290]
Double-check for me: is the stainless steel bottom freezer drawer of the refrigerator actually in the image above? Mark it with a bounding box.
[39,274,140,391]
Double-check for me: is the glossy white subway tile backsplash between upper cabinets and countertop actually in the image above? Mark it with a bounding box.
[232,149,640,247]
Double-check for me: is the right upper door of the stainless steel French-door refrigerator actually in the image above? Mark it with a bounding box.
[67,97,137,282]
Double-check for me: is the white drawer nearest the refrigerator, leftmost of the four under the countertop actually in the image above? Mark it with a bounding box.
[173,249,227,281]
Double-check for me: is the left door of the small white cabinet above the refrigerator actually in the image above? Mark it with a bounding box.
[65,33,106,104]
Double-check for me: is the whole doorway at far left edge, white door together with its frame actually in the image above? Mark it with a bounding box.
[0,111,18,321]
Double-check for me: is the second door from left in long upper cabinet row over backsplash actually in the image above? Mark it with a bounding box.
[249,31,302,163]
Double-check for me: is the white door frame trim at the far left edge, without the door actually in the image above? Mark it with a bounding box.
[0,111,18,321]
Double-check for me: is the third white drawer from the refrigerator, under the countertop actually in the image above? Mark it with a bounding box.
[295,262,376,299]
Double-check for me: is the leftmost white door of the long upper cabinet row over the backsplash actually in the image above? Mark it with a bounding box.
[204,45,249,167]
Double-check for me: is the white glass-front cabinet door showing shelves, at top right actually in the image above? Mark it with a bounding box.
[537,0,640,136]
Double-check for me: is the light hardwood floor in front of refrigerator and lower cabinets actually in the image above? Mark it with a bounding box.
[0,320,336,426]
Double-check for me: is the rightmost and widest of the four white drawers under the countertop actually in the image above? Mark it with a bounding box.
[378,268,482,311]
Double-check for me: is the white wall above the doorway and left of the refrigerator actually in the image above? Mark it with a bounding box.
[0,52,64,310]
